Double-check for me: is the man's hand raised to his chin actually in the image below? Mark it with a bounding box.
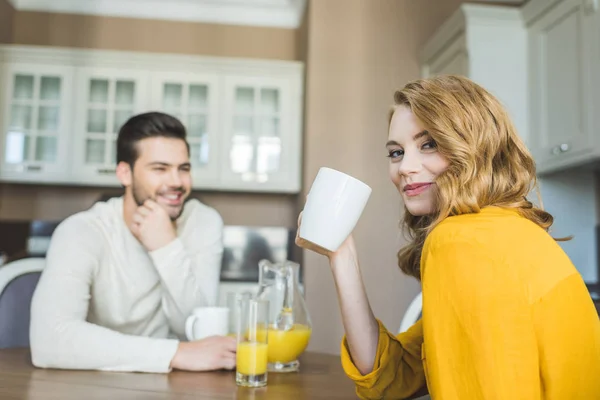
[131,200,177,251]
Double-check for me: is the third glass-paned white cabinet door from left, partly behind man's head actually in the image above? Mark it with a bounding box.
[152,73,219,189]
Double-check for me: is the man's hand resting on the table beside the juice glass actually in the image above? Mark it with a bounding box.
[171,336,237,371]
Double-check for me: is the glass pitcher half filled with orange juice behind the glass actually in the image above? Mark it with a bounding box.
[257,260,312,372]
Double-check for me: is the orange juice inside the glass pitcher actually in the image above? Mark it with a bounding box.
[263,324,312,363]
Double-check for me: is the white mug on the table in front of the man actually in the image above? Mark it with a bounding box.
[185,307,229,340]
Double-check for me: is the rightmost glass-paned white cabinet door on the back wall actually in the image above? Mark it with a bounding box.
[221,76,301,193]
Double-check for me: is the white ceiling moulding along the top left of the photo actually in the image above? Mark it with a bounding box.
[3,0,307,29]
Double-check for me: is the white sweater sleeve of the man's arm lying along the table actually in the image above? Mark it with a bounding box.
[30,216,178,372]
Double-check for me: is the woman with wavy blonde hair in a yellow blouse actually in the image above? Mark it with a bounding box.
[297,76,600,400]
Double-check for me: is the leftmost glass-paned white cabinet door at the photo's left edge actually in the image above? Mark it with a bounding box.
[0,64,73,183]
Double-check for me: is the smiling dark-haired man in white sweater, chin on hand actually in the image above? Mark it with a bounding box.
[30,113,235,372]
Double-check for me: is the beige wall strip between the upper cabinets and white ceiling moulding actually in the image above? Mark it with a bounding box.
[14,11,298,60]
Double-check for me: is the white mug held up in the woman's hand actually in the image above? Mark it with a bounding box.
[299,167,372,251]
